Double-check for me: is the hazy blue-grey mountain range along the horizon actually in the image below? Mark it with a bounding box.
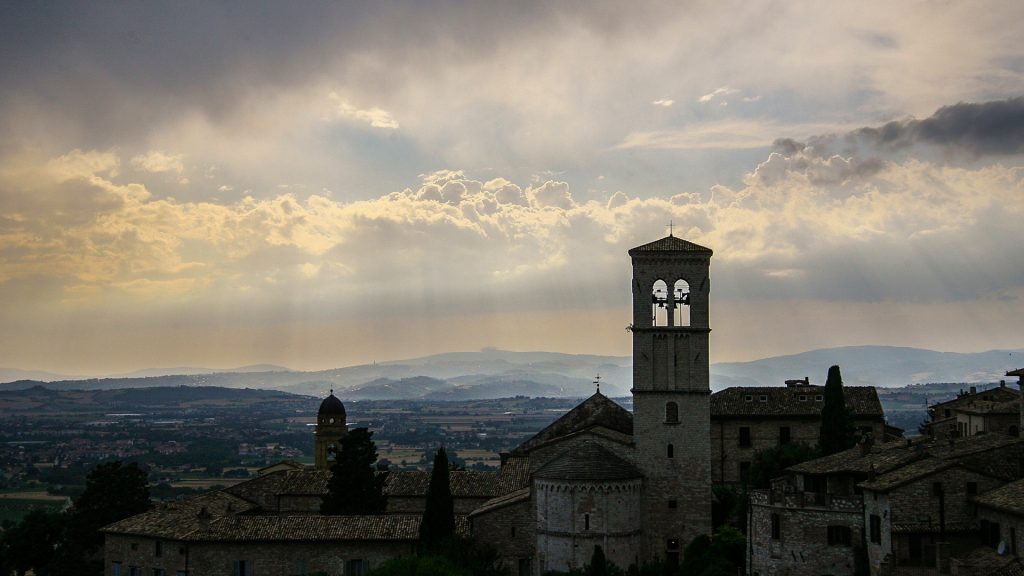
[0,346,1024,400]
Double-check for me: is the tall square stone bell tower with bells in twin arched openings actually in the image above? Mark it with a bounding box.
[629,234,712,564]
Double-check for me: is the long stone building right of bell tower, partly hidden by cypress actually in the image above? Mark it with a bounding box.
[711,380,902,485]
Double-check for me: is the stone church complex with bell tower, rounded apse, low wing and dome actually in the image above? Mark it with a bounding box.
[103,234,712,576]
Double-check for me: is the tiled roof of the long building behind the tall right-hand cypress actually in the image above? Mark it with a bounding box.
[711,385,885,419]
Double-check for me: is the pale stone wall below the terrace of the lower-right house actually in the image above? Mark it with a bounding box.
[748,490,864,576]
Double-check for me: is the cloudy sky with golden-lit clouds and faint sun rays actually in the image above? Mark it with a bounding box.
[0,0,1024,375]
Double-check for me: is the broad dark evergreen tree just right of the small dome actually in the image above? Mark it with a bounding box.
[321,428,387,515]
